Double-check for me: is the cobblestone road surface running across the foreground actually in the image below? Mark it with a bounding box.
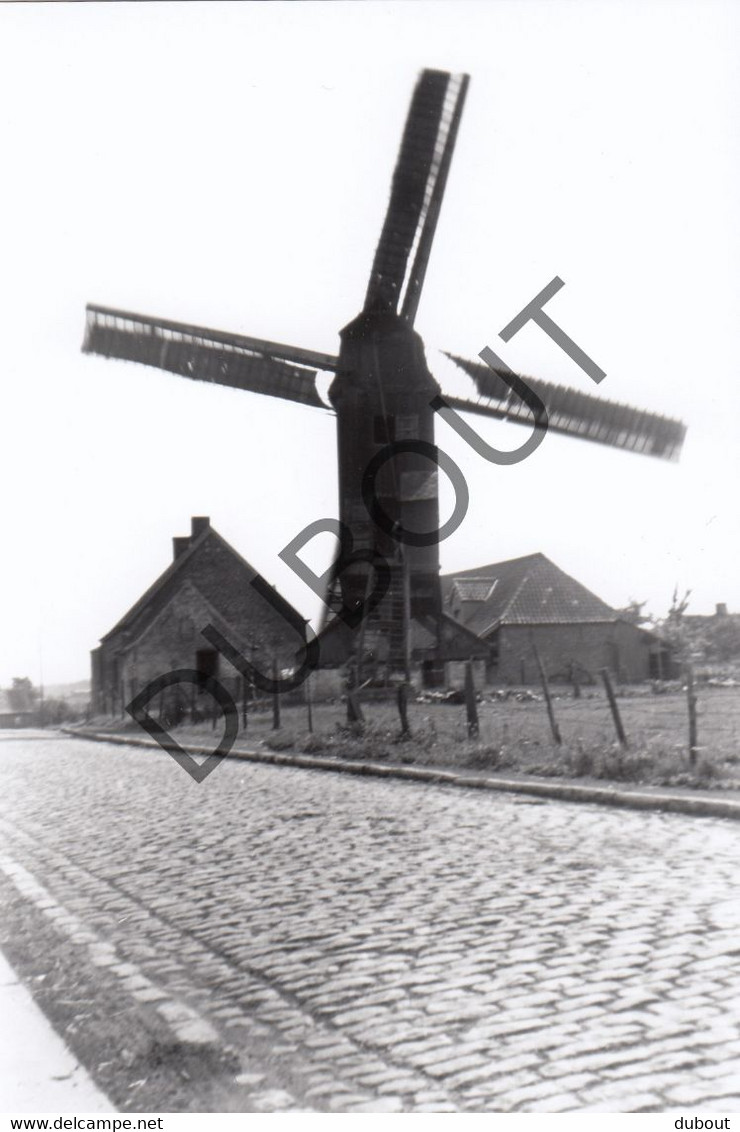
[0,737,740,1112]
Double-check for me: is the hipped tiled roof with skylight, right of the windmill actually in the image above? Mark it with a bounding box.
[442,554,618,636]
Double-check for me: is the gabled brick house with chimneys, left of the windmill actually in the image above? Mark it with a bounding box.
[92,516,306,715]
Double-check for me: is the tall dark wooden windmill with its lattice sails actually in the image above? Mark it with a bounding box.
[83,70,685,683]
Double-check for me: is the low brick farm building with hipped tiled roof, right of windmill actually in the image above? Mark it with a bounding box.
[442,554,672,684]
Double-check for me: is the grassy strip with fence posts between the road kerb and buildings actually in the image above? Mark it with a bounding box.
[148,687,740,789]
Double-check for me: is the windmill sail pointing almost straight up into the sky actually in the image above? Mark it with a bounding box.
[364,70,467,323]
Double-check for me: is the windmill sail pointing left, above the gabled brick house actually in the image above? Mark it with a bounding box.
[83,306,336,409]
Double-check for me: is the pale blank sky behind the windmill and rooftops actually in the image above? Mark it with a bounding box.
[0,0,740,686]
